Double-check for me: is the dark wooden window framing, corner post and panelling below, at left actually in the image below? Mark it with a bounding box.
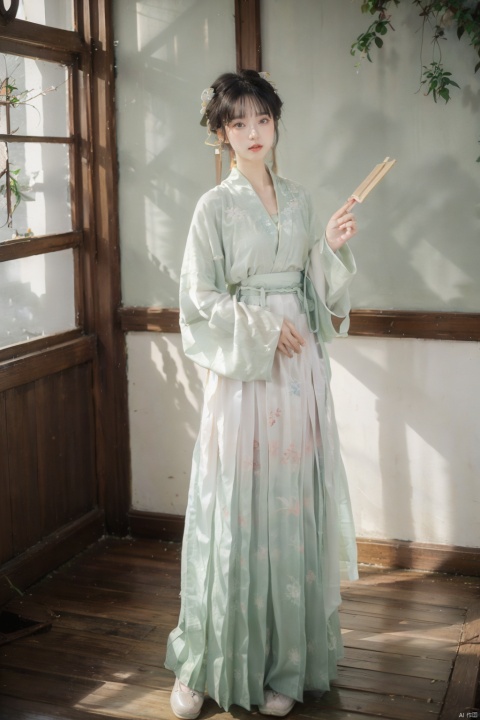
[0,0,126,589]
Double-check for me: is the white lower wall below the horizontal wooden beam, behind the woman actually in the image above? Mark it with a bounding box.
[128,333,480,547]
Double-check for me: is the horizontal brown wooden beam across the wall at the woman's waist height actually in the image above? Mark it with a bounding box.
[118,307,480,342]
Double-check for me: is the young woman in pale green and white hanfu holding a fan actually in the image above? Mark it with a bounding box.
[166,70,356,718]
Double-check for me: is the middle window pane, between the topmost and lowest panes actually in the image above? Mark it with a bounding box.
[0,143,72,242]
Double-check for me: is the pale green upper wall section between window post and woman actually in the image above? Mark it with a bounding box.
[115,0,235,307]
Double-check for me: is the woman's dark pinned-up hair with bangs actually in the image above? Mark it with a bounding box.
[205,70,283,144]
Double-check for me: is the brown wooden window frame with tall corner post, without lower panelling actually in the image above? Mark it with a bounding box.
[0,0,131,535]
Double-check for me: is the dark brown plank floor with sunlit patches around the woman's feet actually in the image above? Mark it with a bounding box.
[0,539,480,720]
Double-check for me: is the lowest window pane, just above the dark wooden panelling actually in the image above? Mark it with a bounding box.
[0,250,75,347]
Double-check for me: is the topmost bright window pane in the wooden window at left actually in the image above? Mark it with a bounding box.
[0,55,69,137]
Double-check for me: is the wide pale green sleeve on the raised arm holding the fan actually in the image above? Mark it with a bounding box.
[306,191,357,342]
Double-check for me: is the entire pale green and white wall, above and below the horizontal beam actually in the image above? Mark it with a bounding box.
[116,0,480,547]
